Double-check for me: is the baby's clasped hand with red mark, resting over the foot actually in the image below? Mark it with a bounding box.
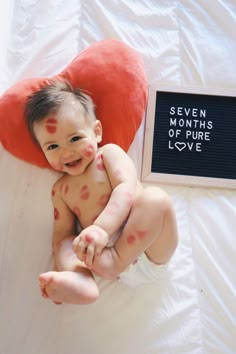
[73,225,109,268]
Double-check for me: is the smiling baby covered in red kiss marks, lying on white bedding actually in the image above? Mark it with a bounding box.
[25,81,178,304]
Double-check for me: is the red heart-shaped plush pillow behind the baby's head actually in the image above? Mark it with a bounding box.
[0,39,148,167]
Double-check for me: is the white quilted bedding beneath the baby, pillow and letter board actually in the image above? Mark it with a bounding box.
[0,0,236,354]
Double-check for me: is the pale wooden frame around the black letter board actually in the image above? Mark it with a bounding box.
[142,84,236,189]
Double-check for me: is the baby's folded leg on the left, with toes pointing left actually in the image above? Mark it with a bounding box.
[39,237,99,304]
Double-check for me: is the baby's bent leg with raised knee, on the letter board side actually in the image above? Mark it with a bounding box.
[93,187,178,279]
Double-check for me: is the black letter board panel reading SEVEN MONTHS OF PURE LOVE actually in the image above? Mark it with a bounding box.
[151,91,236,179]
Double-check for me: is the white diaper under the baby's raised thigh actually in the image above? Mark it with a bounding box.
[118,253,168,288]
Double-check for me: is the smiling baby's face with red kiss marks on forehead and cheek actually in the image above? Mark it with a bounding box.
[34,110,102,175]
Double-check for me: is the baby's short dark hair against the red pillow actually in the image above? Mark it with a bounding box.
[24,80,96,143]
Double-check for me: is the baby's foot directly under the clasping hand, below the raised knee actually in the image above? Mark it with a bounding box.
[91,247,120,280]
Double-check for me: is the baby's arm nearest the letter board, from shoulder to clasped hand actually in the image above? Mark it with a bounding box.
[73,144,137,267]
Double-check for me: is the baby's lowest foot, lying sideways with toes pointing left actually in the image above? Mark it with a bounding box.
[39,269,99,304]
